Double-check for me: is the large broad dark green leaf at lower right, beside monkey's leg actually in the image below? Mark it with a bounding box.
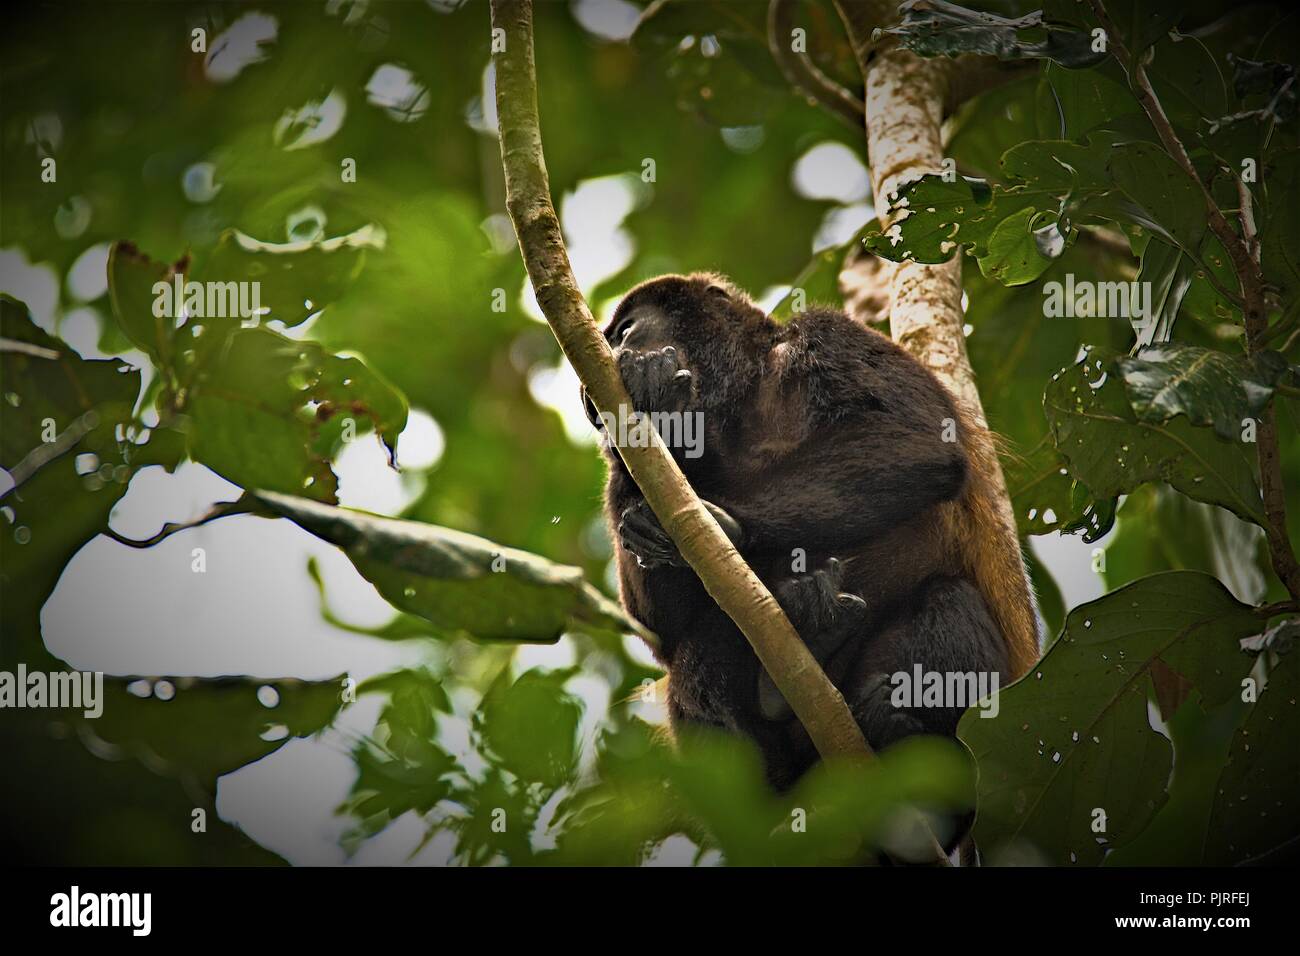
[958,571,1258,865]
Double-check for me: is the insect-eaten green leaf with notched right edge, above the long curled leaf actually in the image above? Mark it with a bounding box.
[186,328,407,501]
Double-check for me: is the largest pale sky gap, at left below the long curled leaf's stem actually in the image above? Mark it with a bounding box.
[48,515,408,680]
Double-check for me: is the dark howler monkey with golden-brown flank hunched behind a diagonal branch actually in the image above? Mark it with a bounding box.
[584,274,1037,788]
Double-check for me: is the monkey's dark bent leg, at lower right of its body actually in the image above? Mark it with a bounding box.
[845,578,1008,750]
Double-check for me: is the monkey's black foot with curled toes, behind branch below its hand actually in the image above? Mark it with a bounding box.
[758,558,867,721]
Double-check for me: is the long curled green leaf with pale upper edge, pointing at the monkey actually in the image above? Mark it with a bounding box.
[255,492,646,644]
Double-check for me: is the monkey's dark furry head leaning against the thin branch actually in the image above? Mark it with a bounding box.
[582,272,781,428]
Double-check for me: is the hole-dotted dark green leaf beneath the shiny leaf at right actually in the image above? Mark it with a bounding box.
[1043,350,1265,527]
